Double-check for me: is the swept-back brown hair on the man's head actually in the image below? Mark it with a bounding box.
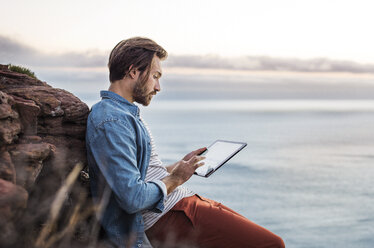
[108,37,168,83]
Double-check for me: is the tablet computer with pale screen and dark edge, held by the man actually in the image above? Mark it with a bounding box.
[195,140,247,177]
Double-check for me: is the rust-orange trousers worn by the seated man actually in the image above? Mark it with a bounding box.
[146,195,285,248]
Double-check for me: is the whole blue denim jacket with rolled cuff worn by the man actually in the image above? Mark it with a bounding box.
[86,91,167,247]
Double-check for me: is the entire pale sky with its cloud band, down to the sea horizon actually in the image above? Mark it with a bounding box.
[0,0,374,105]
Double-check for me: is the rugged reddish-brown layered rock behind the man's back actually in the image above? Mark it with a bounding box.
[0,65,89,246]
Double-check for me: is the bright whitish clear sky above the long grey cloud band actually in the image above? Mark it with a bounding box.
[0,0,374,64]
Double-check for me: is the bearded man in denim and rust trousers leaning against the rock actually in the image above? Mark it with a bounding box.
[86,37,284,247]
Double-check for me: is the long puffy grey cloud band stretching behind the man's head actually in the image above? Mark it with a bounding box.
[0,36,374,73]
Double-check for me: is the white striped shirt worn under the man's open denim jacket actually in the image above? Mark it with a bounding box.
[140,117,195,230]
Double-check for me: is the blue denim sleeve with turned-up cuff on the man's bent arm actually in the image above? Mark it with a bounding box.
[88,120,167,214]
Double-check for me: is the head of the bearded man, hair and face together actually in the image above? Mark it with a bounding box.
[108,37,167,106]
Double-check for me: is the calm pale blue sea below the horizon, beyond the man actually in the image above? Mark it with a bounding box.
[142,101,374,248]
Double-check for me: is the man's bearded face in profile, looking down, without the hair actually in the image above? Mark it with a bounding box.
[133,56,162,106]
